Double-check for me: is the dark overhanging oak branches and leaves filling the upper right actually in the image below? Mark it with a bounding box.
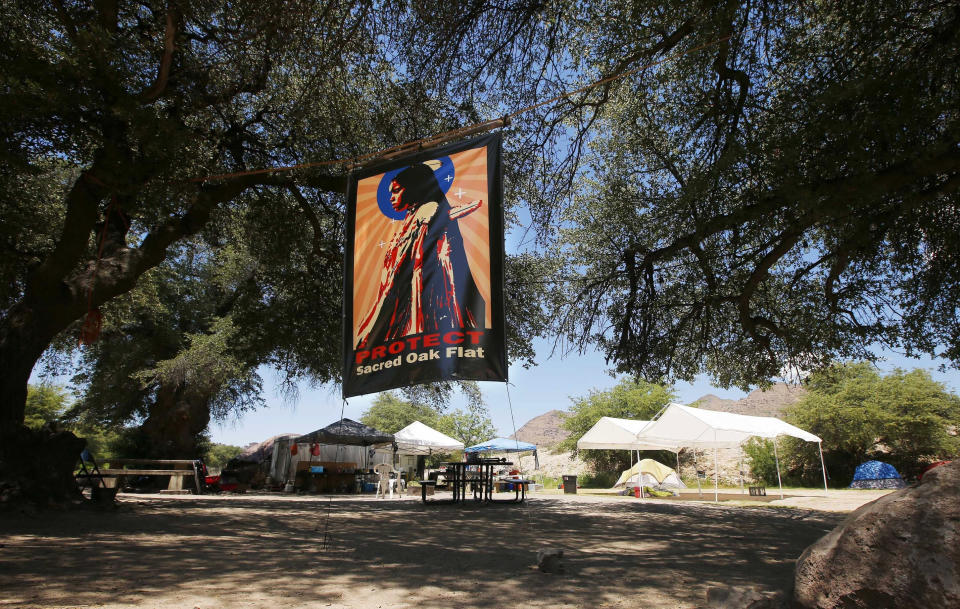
[548,0,960,389]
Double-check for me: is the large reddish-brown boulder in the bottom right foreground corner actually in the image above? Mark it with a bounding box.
[794,461,960,609]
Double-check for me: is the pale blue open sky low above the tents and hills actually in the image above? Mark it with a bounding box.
[210,342,960,446]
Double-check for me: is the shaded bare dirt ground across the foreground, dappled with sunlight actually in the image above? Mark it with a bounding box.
[0,491,883,609]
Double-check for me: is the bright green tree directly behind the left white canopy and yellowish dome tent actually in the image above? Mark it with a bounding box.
[557,378,674,472]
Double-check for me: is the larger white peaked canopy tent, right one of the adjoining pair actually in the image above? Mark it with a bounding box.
[637,404,827,500]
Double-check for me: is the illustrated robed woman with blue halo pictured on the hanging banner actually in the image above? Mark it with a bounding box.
[357,163,486,349]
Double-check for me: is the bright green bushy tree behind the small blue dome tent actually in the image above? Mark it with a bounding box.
[772,362,960,485]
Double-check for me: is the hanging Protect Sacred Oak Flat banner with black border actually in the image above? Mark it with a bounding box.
[343,134,507,397]
